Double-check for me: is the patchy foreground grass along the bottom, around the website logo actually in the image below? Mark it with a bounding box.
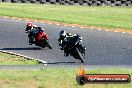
[0,67,132,88]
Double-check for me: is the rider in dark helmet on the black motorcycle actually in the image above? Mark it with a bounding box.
[58,30,86,56]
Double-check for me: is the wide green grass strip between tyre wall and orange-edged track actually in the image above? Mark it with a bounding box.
[0,3,132,29]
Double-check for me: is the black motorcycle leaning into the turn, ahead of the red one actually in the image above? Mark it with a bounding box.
[60,37,85,63]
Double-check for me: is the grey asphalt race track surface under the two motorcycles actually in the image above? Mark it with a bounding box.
[0,18,132,66]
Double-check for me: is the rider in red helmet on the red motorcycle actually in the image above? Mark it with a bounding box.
[25,22,47,45]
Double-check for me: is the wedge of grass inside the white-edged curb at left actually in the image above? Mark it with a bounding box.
[0,52,39,65]
